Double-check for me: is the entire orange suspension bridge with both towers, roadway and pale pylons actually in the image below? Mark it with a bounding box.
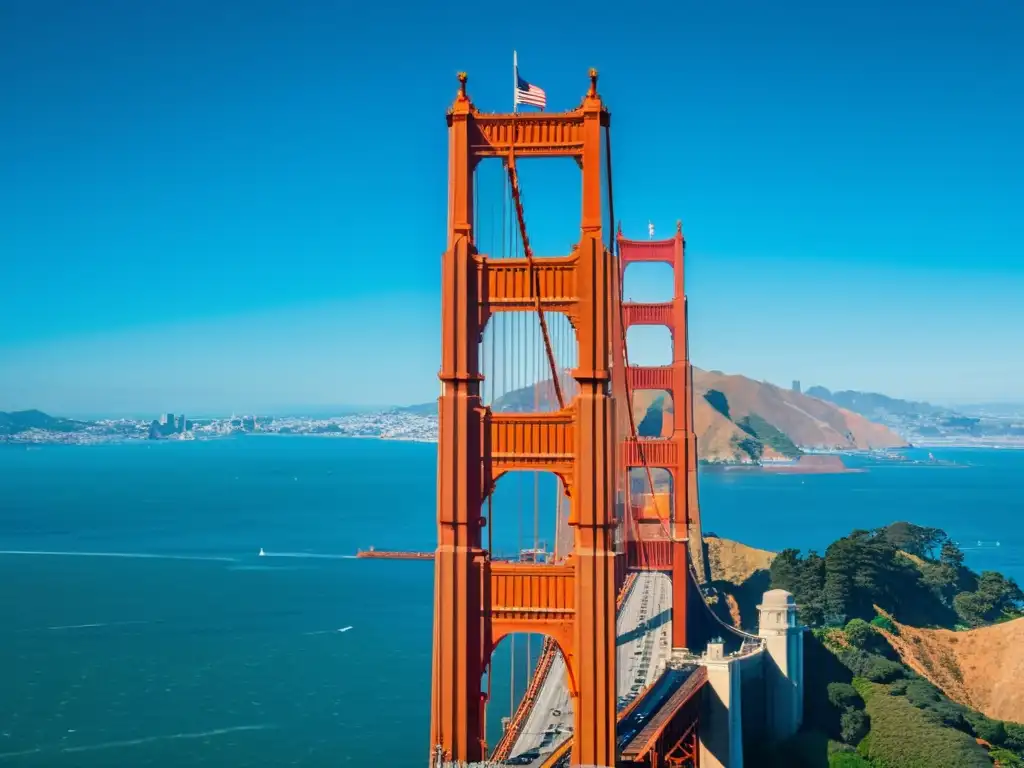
[407,70,802,768]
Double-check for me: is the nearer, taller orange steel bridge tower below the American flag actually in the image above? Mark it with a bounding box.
[430,70,617,766]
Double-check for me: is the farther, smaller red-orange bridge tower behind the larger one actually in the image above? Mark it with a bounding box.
[617,223,701,648]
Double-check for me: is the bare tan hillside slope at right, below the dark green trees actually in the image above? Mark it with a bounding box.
[882,614,1024,723]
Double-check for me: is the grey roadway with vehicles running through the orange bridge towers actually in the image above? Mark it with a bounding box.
[505,571,672,765]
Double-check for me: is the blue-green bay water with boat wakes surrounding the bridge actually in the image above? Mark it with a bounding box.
[0,436,1024,768]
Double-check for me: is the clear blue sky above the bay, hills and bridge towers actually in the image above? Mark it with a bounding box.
[0,0,1024,414]
